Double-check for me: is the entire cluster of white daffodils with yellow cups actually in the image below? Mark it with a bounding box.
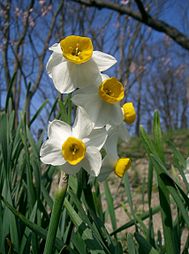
[40,35,136,181]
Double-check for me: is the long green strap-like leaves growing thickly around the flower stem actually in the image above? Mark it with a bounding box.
[0,91,189,254]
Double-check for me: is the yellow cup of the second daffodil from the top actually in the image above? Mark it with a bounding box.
[98,78,124,104]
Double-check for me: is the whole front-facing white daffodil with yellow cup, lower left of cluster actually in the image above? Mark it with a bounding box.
[40,108,107,176]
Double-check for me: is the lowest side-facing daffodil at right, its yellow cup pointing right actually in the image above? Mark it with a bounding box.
[97,153,131,182]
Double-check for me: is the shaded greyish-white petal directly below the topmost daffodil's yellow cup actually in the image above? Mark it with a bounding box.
[67,60,102,88]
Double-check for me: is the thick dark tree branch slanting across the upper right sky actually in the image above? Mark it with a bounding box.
[72,0,189,50]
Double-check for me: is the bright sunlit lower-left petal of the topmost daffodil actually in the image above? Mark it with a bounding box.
[51,62,76,93]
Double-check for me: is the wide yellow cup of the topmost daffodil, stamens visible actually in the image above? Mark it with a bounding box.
[60,35,93,64]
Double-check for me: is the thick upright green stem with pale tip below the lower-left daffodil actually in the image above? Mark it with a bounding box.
[44,172,68,254]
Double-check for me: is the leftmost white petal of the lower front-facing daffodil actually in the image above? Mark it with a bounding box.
[40,139,65,166]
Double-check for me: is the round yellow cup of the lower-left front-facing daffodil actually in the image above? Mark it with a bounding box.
[62,137,86,165]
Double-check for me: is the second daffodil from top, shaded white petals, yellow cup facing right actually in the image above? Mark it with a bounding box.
[72,75,124,128]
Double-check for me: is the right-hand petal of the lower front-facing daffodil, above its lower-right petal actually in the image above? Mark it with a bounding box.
[86,128,108,151]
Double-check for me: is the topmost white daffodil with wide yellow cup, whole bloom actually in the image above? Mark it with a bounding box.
[47,35,117,93]
